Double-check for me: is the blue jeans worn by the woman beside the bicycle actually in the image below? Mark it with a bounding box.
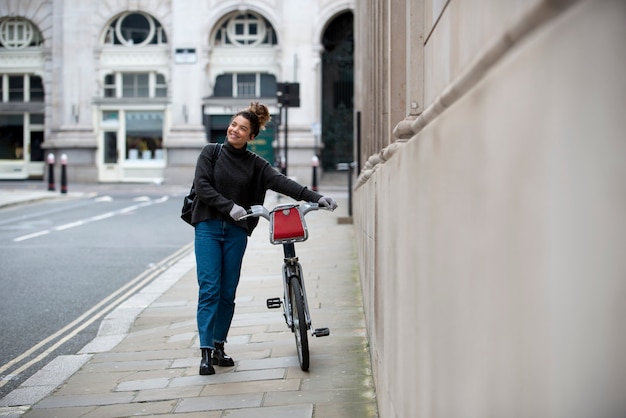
[195,219,248,348]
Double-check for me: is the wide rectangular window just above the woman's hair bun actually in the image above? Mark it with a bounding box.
[213,73,276,97]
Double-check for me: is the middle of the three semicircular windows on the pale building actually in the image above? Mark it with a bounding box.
[104,12,167,47]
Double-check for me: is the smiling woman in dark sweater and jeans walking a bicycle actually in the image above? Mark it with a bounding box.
[191,102,337,375]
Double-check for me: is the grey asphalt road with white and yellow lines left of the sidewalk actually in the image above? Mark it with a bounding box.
[0,185,193,398]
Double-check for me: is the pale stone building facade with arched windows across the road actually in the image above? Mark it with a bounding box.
[0,0,354,184]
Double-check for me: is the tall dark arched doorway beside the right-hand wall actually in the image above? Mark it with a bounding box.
[322,12,354,170]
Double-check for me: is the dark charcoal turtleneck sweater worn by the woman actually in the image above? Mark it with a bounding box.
[191,142,322,235]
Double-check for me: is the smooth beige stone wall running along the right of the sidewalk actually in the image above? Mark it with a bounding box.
[354,0,626,418]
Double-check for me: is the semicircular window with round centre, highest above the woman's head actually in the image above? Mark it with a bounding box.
[214,13,277,46]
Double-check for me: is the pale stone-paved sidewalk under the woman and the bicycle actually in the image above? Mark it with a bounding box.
[0,185,378,418]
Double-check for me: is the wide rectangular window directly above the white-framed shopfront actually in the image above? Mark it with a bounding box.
[102,73,167,98]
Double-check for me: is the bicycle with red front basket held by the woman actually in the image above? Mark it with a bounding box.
[242,203,330,371]
